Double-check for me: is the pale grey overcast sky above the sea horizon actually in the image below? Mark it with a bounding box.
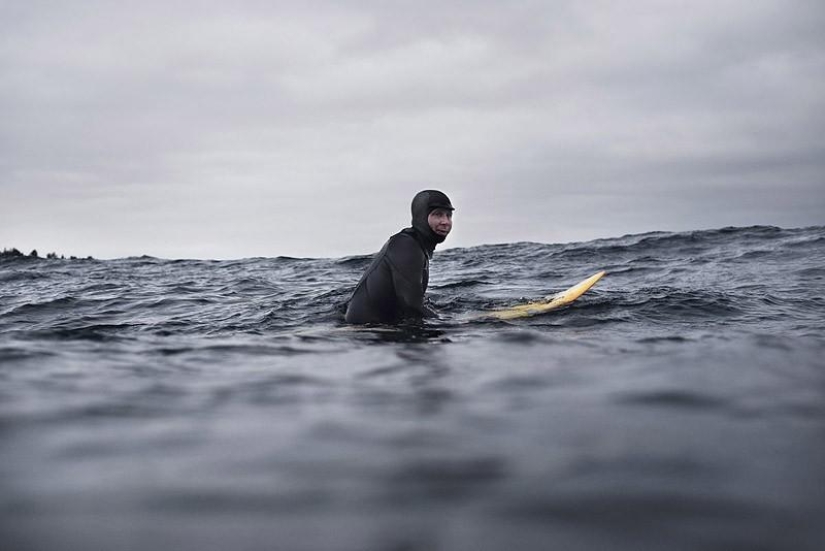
[0,0,825,258]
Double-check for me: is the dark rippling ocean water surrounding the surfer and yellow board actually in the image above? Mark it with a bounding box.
[0,227,825,551]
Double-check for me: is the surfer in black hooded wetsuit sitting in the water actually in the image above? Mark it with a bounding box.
[346,190,455,324]
